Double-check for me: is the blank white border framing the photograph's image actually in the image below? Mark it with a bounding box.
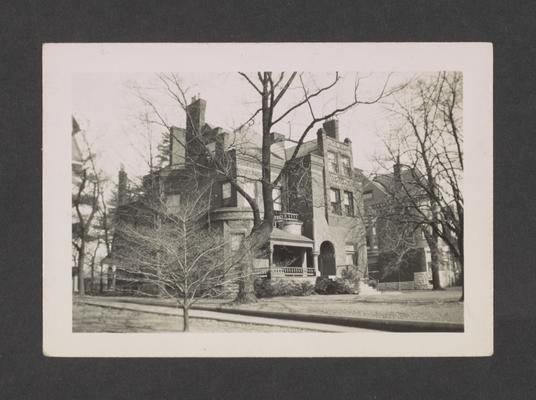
[43,43,493,357]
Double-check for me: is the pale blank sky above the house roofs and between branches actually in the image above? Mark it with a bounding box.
[72,72,413,183]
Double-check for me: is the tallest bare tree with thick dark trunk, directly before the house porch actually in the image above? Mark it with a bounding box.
[127,72,400,302]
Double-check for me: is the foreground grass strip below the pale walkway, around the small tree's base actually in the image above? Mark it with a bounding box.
[73,301,304,333]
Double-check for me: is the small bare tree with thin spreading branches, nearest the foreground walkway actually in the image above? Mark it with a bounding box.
[114,185,248,331]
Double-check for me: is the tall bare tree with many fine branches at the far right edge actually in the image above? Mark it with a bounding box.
[378,72,463,298]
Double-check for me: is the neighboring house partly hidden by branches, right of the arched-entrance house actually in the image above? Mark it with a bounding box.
[363,163,460,289]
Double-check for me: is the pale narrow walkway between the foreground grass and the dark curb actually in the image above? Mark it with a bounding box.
[78,297,378,333]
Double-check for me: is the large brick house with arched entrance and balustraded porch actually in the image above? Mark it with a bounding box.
[112,98,367,284]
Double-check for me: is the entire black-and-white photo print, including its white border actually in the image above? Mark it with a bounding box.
[43,44,493,357]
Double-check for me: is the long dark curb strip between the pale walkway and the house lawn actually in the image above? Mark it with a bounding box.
[89,299,464,333]
